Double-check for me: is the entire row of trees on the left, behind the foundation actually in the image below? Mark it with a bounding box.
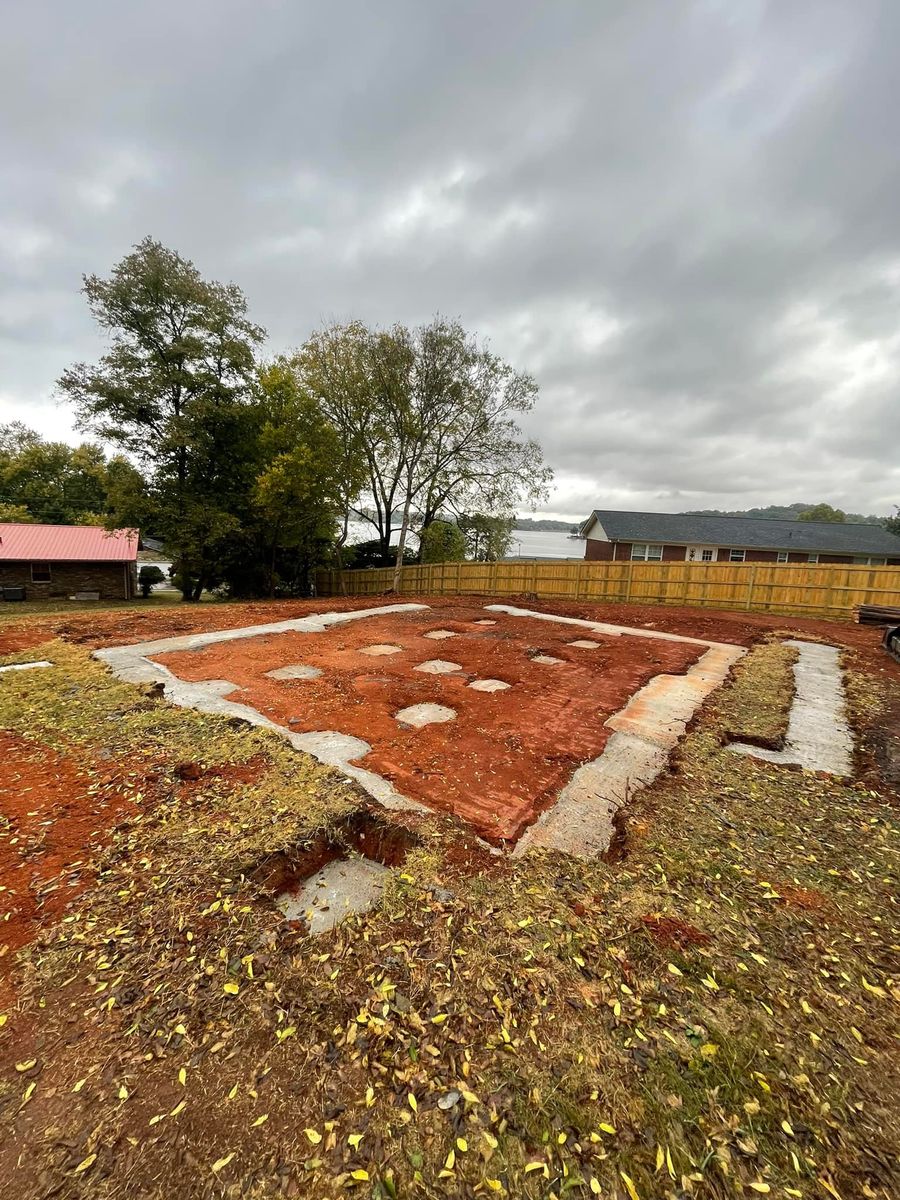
[0,238,552,600]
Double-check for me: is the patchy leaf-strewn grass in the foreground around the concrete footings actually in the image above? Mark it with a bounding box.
[0,643,900,1200]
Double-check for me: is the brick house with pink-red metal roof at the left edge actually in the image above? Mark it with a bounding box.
[0,522,138,600]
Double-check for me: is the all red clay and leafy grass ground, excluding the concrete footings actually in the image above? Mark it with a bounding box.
[0,596,900,1200]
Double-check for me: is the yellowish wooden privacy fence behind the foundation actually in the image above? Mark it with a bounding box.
[316,559,900,619]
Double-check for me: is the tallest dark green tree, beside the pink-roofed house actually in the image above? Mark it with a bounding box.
[59,238,264,600]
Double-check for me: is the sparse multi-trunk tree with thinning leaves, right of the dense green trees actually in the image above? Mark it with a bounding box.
[294,317,552,588]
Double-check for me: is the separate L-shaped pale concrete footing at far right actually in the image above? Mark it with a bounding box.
[728,641,853,775]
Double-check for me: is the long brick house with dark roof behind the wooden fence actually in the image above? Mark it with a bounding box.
[581,509,900,566]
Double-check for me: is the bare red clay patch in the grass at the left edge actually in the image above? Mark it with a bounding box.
[0,732,134,980]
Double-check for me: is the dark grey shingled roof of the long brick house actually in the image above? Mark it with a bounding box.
[584,509,900,558]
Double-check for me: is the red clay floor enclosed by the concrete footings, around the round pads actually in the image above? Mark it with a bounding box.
[158,605,702,842]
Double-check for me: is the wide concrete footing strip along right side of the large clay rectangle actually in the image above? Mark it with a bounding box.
[512,646,746,858]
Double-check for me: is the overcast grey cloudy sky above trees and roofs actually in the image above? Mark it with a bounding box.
[0,0,900,517]
